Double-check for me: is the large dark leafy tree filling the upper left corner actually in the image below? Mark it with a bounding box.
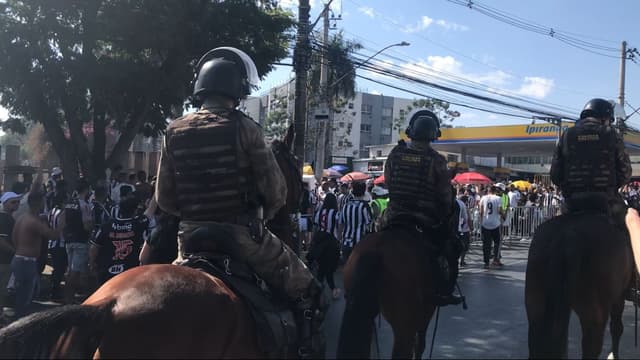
[0,0,293,186]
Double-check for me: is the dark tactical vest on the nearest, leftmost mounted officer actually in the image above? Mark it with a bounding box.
[167,111,251,223]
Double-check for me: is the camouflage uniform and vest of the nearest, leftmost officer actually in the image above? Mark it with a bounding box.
[156,106,313,299]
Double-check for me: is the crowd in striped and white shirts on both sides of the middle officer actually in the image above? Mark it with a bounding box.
[301,178,563,297]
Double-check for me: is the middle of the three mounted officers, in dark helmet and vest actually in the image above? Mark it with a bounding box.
[381,109,462,306]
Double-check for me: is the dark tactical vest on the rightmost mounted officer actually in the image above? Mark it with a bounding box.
[562,126,616,195]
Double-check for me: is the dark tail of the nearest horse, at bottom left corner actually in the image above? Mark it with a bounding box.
[0,301,115,359]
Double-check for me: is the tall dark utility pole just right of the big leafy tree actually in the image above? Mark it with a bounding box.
[293,0,311,170]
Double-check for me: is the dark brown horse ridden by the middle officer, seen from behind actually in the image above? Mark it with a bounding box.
[337,227,436,358]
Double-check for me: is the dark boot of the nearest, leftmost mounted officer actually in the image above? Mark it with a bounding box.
[294,280,327,359]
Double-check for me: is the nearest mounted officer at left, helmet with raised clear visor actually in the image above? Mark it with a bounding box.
[156,47,321,353]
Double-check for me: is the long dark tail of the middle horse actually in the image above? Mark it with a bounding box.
[336,252,382,359]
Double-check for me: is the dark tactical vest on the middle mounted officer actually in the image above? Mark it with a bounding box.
[387,141,442,218]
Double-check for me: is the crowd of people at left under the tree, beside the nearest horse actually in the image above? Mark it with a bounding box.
[0,166,170,321]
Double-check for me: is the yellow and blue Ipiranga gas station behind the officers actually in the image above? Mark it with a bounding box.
[353,122,640,180]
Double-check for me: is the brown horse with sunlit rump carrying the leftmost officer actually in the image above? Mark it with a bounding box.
[0,124,300,358]
